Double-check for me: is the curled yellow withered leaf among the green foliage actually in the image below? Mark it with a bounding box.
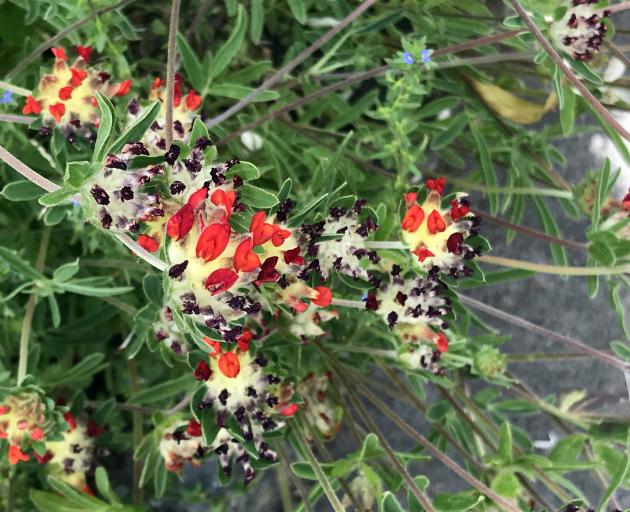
[465,76,557,124]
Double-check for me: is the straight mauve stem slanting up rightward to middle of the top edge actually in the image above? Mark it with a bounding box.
[206,0,376,128]
